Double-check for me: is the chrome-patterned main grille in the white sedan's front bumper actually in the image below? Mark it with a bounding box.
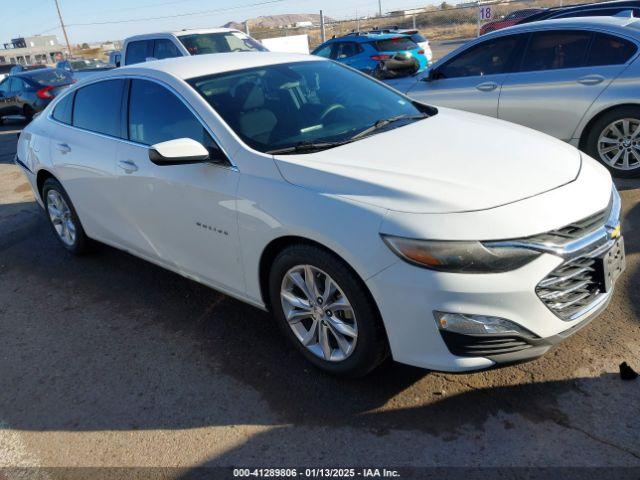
[536,254,603,320]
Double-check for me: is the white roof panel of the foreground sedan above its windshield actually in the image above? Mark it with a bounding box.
[111,52,329,79]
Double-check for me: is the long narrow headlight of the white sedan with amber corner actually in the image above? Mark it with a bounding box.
[382,235,540,273]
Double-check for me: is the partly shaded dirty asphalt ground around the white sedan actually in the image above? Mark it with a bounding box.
[0,117,640,478]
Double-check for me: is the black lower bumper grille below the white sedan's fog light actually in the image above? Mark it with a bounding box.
[440,330,532,357]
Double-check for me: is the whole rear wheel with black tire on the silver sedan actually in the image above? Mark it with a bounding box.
[584,107,640,178]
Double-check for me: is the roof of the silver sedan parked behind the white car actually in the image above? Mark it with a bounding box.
[480,17,640,39]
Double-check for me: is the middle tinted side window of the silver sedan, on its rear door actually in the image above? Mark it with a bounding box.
[520,30,591,72]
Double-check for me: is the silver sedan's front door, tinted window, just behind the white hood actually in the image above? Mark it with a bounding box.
[408,34,526,117]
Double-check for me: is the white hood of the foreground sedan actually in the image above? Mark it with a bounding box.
[274,108,581,213]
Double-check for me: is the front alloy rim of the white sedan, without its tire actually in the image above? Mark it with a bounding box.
[280,265,358,362]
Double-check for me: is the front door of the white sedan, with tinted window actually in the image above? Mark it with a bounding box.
[111,79,244,292]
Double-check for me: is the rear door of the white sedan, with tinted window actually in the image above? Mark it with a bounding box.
[49,79,127,245]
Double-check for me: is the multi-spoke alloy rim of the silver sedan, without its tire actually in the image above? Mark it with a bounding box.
[597,118,640,170]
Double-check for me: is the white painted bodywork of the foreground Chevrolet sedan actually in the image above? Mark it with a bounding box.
[17,53,619,372]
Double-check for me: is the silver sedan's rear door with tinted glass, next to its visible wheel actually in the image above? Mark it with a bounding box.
[498,30,637,141]
